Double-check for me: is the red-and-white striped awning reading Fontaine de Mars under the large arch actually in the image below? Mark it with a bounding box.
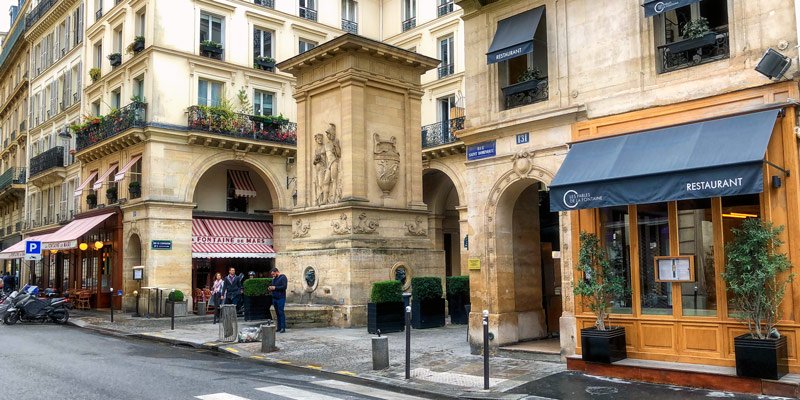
[192,218,275,258]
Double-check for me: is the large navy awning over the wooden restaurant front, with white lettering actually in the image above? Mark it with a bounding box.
[550,110,778,211]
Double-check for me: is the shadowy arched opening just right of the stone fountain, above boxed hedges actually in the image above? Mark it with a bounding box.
[422,169,465,276]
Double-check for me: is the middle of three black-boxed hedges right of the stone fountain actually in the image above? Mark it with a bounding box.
[411,276,445,329]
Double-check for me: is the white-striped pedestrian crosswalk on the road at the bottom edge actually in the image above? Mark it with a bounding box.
[195,380,432,400]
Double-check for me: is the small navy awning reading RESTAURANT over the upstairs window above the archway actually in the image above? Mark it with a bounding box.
[486,6,544,64]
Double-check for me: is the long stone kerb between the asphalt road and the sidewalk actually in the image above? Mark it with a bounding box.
[67,319,468,399]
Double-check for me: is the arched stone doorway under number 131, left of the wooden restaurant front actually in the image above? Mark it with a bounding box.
[496,179,562,346]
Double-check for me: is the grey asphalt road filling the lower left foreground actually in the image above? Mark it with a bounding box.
[0,324,438,400]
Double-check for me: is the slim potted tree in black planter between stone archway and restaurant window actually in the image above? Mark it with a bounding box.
[574,232,628,364]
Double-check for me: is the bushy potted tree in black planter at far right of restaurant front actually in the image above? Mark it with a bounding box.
[722,218,793,380]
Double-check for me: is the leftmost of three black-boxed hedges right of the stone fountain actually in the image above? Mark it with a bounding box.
[367,280,405,334]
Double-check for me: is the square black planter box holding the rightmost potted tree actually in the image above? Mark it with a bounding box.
[733,333,789,380]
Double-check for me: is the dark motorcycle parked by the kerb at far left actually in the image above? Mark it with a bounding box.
[3,292,71,325]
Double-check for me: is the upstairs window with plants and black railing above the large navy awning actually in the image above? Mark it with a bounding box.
[653,0,730,73]
